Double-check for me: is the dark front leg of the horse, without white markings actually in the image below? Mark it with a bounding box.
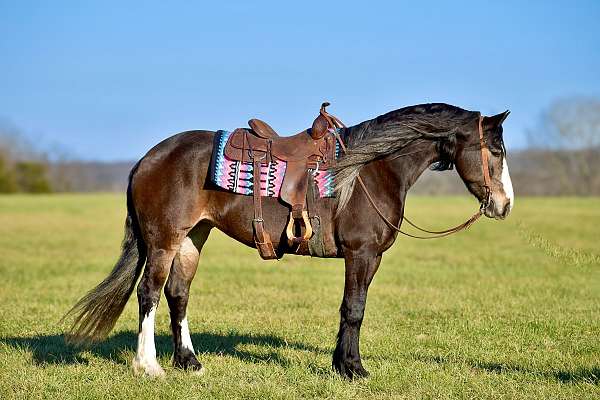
[333,251,381,378]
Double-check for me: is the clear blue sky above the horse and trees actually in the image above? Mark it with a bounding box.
[0,0,600,160]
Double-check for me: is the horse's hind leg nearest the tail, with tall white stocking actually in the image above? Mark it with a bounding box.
[133,248,177,377]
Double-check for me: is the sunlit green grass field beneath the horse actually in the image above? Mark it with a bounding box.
[0,195,600,399]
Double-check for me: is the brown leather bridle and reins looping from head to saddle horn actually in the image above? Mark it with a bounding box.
[320,103,492,239]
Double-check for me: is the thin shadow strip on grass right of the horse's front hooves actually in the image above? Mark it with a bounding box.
[413,355,600,385]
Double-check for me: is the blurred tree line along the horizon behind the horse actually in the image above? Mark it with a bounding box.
[0,97,600,196]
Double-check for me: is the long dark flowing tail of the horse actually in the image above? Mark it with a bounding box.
[63,162,147,345]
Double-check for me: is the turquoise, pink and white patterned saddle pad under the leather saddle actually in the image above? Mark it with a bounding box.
[210,130,339,197]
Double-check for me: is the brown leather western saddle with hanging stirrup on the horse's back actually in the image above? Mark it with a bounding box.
[225,102,343,260]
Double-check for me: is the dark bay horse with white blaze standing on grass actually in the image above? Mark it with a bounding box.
[70,104,514,378]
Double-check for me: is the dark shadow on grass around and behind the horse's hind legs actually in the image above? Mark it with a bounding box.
[0,332,329,366]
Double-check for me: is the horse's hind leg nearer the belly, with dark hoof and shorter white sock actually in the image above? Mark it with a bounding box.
[165,225,210,374]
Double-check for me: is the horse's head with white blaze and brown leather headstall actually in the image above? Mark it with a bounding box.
[455,111,515,219]
